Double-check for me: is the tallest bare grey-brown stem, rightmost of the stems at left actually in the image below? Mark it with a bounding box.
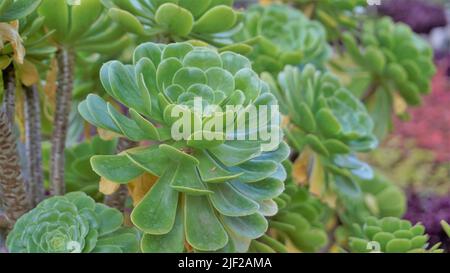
[50,49,75,195]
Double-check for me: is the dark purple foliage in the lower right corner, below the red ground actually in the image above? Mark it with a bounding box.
[405,191,450,252]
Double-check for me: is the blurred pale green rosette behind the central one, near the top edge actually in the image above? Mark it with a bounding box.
[234,4,330,73]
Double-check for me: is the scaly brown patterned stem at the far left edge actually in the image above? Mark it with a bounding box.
[0,109,30,225]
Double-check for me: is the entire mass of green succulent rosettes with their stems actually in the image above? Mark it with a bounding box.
[0,0,446,253]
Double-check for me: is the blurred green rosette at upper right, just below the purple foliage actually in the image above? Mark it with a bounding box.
[343,17,435,105]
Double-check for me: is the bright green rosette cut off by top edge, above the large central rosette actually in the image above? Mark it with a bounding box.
[104,0,239,46]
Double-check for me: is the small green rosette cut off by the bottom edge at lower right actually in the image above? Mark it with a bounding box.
[350,217,442,253]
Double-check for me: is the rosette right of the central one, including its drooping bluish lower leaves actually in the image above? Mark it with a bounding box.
[262,65,378,196]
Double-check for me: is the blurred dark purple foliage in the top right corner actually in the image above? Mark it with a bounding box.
[378,0,447,33]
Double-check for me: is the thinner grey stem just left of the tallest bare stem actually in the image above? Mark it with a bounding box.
[24,85,45,207]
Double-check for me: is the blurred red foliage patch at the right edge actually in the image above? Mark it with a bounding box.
[394,60,450,162]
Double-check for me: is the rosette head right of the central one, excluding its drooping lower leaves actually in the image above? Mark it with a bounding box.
[263,65,378,155]
